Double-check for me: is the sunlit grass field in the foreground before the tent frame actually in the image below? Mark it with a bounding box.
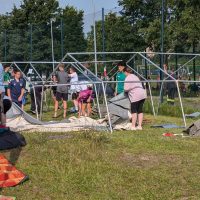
[1,115,200,200]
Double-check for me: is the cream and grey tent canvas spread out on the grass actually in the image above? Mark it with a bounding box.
[7,104,108,132]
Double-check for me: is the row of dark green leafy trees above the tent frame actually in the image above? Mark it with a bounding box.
[0,0,200,64]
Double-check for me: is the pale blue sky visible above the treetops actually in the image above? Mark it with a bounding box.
[0,0,120,33]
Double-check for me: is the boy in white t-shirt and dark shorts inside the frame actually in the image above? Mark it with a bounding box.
[69,67,79,112]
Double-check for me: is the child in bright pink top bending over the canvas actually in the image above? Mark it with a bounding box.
[78,85,94,117]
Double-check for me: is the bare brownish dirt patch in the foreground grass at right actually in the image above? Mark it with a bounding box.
[119,153,181,168]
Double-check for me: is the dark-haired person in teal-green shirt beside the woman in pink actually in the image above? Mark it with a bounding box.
[115,62,126,96]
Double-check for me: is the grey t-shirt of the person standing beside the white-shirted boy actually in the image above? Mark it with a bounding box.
[56,71,68,94]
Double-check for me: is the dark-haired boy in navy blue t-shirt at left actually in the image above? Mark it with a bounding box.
[8,69,25,108]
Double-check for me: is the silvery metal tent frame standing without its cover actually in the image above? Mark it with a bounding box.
[2,52,200,132]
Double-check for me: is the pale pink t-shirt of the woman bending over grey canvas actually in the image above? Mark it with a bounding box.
[124,74,147,102]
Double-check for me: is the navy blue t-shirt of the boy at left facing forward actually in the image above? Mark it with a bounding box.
[8,79,25,102]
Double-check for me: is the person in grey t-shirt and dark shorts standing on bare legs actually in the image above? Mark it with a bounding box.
[54,64,69,118]
